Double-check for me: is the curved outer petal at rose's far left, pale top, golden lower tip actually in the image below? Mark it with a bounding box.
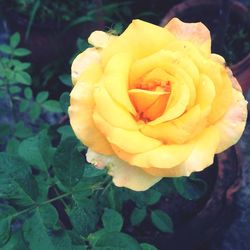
[69,82,113,154]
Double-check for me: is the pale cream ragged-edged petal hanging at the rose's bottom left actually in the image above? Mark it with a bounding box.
[87,150,161,191]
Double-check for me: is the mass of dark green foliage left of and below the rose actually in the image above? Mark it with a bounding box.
[0,29,211,250]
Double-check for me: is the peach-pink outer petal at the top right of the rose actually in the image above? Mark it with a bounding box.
[165,18,211,54]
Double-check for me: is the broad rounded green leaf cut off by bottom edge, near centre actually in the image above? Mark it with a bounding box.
[93,232,141,250]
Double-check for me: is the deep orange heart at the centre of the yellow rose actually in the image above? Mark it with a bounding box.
[128,80,171,123]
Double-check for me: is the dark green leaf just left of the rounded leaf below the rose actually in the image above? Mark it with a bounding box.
[68,199,99,236]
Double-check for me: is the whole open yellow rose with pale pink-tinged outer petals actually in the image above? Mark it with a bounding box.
[69,18,247,191]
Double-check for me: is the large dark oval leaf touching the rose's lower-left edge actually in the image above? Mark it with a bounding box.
[53,137,85,189]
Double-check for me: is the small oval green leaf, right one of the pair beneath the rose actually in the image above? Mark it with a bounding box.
[151,210,173,233]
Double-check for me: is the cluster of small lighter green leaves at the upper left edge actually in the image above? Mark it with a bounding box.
[0,33,63,148]
